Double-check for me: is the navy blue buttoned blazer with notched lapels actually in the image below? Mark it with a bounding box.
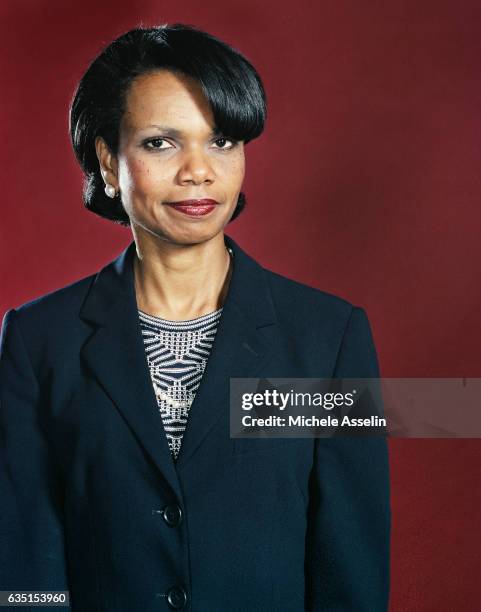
[0,236,390,612]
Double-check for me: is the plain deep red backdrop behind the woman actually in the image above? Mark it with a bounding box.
[0,0,481,612]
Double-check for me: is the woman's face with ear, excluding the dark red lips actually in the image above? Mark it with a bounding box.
[97,70,245,244]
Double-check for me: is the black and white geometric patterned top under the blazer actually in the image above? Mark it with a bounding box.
[138,308,223,461]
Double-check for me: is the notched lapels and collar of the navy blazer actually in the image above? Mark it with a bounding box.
[80,235,276,493]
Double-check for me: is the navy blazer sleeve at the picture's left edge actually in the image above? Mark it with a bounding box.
[0,309,68,596]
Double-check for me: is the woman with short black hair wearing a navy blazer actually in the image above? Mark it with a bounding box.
[0,24,390,612]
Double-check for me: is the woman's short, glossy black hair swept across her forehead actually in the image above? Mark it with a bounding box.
[69,23,267,226]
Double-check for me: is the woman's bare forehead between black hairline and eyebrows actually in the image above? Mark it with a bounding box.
[122,70,214,131]
